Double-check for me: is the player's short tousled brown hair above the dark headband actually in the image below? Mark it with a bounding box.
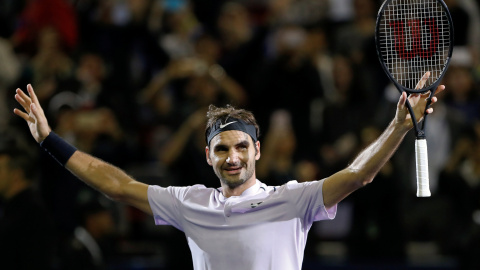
[205,104,260,144]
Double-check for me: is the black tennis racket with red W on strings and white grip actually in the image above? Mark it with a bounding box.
[375,0,453,197]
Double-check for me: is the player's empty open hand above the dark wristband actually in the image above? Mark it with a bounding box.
[13,84,52,143]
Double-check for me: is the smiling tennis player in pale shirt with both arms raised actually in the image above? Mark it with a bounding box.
[14,73,445,270]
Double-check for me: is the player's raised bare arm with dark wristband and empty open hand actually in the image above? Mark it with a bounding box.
[14,84,152,215]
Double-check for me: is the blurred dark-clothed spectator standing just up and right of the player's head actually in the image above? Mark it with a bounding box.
[255,26,323,159]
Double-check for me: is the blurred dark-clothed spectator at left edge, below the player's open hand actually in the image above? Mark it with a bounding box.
[0,133,57,270]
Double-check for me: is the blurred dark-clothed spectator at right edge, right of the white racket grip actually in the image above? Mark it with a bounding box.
[437,125,480,269]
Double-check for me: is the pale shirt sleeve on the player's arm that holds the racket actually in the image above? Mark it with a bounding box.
[285,179,337,224]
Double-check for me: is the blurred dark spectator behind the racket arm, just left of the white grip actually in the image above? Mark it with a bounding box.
[346,126,407,263]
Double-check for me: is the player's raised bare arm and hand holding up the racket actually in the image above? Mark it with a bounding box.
[323,76,445,208]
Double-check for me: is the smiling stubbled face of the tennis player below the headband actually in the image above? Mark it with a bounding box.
[205,130,260,193]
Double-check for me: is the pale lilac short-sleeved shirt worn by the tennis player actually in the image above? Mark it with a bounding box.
[148,180,337,270]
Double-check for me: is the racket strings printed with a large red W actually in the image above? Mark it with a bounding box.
[379,0,453,90]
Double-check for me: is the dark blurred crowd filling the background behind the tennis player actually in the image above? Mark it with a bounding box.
[0,0,480,269]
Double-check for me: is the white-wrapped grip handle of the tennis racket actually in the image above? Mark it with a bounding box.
[415,139,430,197]
